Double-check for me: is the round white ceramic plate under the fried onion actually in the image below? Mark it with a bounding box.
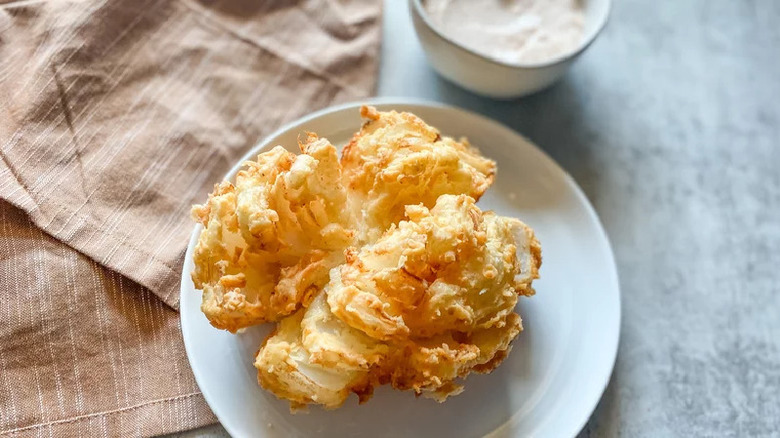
[181,100,620,438]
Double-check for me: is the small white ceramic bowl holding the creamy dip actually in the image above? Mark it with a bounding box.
[409,0,611,99]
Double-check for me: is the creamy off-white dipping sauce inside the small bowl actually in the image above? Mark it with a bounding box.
[423,0,585,64]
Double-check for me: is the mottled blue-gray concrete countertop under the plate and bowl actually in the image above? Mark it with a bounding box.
[169,0,780,438]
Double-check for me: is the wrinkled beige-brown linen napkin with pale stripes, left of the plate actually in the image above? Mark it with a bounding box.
[0,0,381,436]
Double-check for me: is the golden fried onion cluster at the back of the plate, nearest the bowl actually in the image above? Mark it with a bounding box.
[341,107,496,240]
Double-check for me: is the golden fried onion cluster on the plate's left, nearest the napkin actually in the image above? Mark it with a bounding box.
[192,134,355,332]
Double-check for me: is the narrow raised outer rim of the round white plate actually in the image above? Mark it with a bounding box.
[179,97,623,437]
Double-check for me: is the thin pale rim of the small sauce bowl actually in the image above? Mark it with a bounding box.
[409,0,612,69]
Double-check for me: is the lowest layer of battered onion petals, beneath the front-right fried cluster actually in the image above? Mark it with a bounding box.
[255,292,522,409]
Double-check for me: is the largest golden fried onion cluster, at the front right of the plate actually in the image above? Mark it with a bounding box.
[255,195,541,408]
